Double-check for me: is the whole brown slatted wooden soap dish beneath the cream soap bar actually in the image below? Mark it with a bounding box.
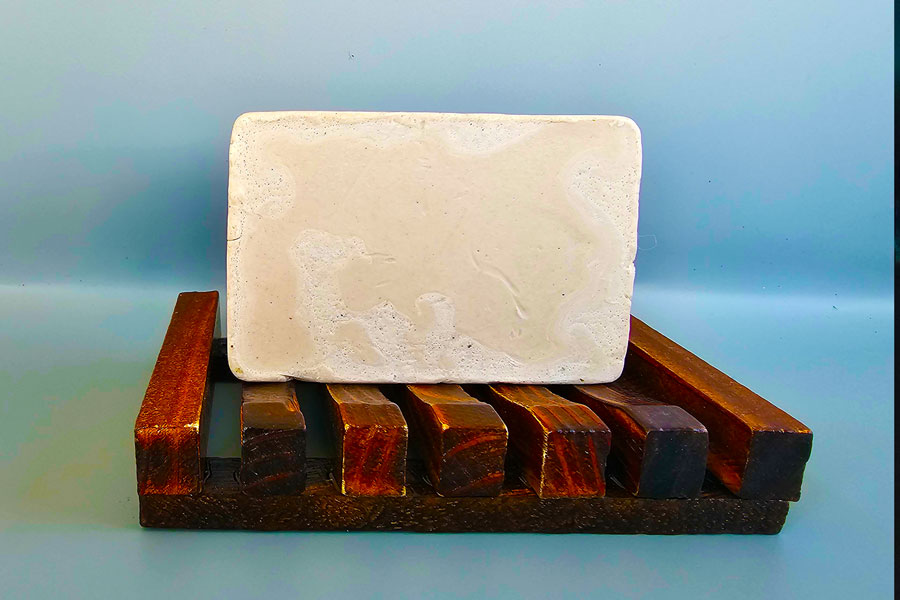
[135,292,812,534]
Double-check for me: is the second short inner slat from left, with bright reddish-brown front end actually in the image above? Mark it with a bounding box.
[326,384,409,496]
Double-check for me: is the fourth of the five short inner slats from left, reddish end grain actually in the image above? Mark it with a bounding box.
[467,384,610,498]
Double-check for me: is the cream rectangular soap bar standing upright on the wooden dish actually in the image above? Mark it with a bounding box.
[227,112,641,383]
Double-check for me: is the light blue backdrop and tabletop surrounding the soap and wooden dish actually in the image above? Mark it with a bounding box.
[0,0,894,598]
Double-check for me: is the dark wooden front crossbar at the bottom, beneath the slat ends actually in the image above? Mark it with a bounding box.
[140,459,788,534]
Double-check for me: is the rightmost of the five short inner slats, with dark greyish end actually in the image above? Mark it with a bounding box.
[560,379,709,498]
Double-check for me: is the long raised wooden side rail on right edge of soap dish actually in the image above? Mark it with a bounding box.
[625,317,812,500]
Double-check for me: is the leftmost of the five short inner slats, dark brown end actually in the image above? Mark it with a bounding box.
[240,382,306,495]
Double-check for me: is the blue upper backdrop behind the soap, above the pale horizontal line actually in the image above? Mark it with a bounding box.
[0,1,893,294]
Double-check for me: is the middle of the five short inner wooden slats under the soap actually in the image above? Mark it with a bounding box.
[398,385,508,496]
